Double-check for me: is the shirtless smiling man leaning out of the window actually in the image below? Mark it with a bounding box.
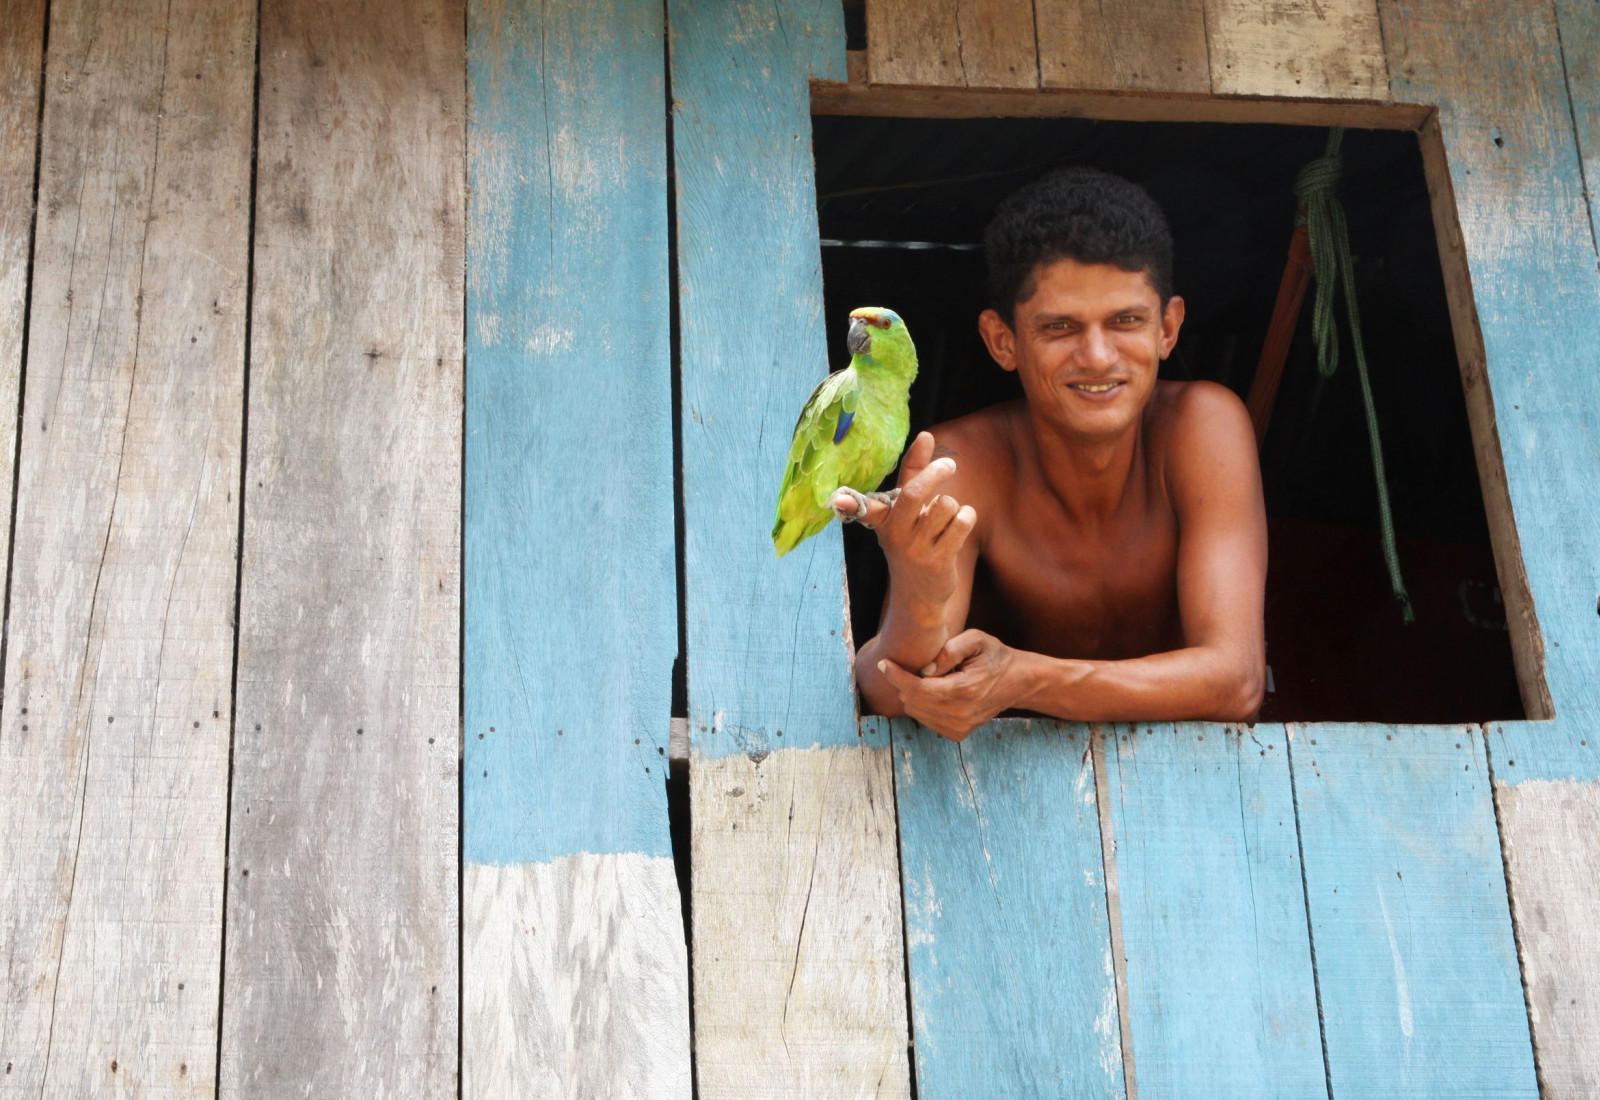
[834,169,1267,740]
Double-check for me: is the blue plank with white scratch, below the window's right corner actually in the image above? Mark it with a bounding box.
[1290,724,1538,1097]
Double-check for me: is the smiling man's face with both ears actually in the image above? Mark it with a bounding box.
[978,259,1184,438]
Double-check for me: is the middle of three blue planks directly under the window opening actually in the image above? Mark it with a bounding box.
[1100,723,1323,1100]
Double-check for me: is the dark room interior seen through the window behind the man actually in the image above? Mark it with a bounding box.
[813,115,1523,723]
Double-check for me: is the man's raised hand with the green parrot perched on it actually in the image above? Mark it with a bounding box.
[830,432,978,611]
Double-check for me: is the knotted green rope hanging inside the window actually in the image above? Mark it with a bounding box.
[1294,128,1416,624]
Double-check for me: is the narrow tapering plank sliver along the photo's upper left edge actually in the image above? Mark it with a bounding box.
[0,0,45,636]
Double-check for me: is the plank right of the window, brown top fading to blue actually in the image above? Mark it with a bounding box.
[1379,0,1600,729]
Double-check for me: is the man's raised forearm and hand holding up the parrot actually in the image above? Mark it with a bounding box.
[835,432,978,715]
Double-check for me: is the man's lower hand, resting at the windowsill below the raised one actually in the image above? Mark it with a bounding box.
[878,630,1026,740]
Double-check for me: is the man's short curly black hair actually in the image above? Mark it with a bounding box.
[984,168,1173,325]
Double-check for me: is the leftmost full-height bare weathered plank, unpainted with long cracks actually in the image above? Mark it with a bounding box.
[0,0,254,1097]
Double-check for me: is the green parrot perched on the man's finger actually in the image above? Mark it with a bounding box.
[773,305,917,558]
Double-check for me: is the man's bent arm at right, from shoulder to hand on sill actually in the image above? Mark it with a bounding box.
[882,384,1267,739]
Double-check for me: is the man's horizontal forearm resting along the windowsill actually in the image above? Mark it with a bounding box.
[1014,646,1264,721]
